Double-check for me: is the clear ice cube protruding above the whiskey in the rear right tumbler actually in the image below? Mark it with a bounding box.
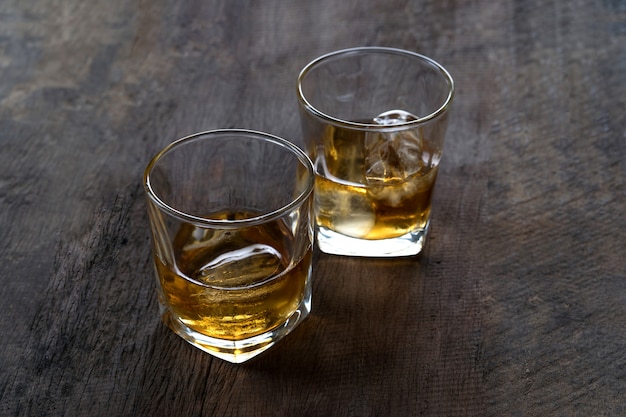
[365,110,432,184]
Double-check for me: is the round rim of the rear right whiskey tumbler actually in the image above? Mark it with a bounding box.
[297,46,454,132]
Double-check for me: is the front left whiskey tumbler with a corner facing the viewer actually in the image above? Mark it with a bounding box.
[144,129,314,363]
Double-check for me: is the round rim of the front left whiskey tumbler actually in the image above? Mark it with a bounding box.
[143,129,315,229]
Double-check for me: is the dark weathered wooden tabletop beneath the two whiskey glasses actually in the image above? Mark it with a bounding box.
[0,0,626,417]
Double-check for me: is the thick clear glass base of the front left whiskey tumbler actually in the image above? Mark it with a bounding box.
[161,279,311,363]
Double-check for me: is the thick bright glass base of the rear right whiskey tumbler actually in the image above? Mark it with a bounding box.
[317,223,428,258]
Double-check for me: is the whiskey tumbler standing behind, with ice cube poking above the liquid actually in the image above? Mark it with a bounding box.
[297,47,454,257]
